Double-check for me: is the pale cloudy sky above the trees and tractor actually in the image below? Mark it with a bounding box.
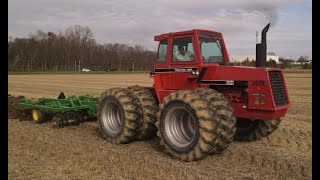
[8,0,312,59]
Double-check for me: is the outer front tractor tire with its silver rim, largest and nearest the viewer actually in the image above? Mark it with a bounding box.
[156,90,220,161]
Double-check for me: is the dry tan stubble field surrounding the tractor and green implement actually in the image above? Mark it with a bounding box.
[8,73,312,179]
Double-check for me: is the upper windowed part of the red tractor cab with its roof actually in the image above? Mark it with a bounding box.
[154,29,229,68]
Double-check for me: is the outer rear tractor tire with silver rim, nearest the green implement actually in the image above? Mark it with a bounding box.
[97,88,142,144]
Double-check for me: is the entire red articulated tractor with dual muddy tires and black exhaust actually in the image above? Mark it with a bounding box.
[98,24,290,161]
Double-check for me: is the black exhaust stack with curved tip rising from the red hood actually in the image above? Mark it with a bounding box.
[256,23,270,68]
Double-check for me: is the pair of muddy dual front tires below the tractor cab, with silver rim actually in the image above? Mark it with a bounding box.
[157,89,236,161]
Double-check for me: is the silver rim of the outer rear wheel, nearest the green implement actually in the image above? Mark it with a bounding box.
[102,102,123,135]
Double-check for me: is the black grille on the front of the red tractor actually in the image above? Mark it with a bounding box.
[269,71,287,106]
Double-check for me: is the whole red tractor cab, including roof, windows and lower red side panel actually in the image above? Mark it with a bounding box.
[153,29,229,93]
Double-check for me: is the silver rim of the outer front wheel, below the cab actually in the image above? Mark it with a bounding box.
[164,107,195,148]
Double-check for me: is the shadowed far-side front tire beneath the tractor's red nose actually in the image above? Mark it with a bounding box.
[235,119,281,142]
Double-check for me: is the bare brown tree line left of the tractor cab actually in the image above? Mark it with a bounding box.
[8,25,156,72]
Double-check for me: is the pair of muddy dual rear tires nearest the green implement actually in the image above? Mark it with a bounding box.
[97,86,157,144]
